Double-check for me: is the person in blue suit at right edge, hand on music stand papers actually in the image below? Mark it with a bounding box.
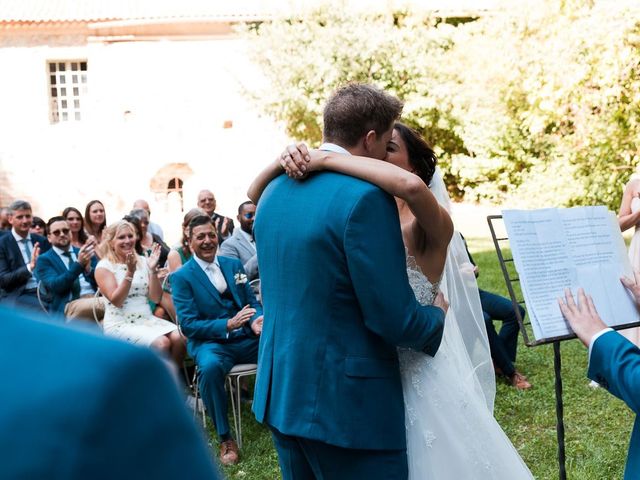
[559,286,640,480]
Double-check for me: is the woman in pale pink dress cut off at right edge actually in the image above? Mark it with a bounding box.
[618,175,640,346]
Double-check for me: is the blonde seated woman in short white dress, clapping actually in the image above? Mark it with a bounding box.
[95,220,185,366]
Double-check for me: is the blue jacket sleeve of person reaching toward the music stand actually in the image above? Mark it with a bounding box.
[588,332,640,480]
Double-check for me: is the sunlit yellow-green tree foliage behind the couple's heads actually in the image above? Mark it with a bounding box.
[240,0,640,208]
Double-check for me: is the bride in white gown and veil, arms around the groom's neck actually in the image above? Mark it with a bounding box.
[249,124,532,480]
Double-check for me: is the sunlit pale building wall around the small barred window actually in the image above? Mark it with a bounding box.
[0,33,287,244]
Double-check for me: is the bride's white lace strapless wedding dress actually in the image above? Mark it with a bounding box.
[399,253,533,480]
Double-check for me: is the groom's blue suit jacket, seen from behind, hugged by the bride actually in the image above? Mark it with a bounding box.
[253,172,444,449]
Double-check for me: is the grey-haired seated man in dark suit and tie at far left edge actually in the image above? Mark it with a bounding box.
[0,200,49,310]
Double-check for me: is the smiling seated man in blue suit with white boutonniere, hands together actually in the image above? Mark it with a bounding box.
[171,215,262,465]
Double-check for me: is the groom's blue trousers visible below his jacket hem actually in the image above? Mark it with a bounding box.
[269,426,409,480]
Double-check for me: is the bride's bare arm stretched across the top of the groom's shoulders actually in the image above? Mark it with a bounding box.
[283,146,453,251]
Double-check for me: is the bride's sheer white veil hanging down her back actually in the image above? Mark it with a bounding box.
[429,169,496,412]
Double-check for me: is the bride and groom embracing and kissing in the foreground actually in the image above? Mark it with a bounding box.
[249,84,531,480]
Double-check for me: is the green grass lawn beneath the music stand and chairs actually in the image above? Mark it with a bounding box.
[209,238,634,480]
